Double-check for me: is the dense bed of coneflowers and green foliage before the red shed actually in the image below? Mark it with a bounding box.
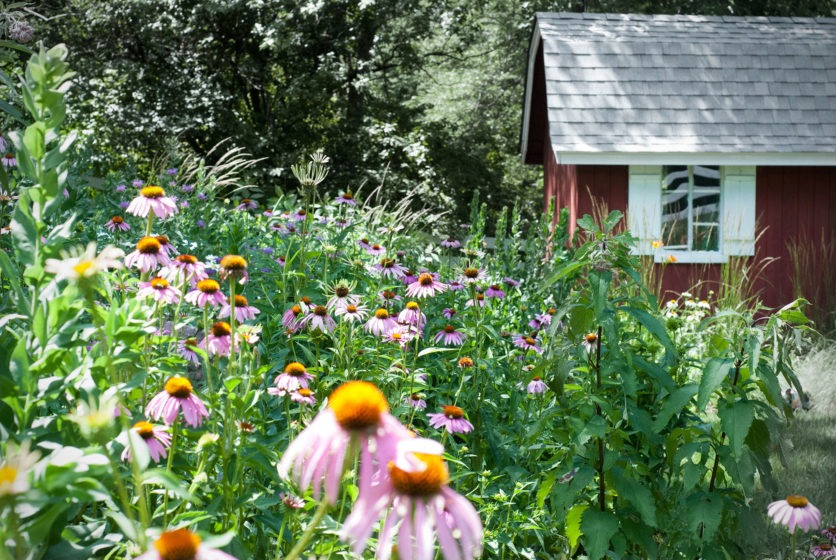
[0,46,824,560]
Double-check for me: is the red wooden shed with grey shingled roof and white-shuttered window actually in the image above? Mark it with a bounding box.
[522,13,836,316]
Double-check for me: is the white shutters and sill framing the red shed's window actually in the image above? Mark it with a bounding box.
[627,165,755,264]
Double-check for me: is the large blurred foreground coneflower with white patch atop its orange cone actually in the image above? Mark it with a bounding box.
[340,438,482,560]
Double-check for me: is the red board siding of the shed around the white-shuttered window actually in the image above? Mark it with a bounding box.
[544,163,836,307]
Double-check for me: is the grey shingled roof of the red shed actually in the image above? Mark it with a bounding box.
[522,13,836,165]
